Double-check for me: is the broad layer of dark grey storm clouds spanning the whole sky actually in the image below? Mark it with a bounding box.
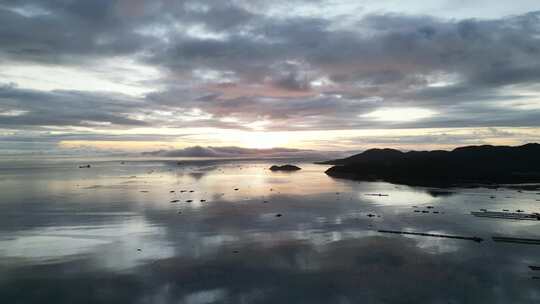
[0,0,540,148]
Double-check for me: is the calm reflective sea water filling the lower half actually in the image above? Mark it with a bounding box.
[0,159,540,304]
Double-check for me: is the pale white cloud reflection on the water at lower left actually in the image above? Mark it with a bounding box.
[0,216,173,269]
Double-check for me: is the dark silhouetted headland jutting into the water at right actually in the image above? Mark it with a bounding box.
[324,143,540,186]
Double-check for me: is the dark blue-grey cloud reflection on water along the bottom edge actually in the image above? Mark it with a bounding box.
[0,236,536,304]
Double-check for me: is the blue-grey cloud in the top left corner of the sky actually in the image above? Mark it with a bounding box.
[0,1,155,64]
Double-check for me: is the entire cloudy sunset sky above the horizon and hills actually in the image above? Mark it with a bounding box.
[0,0,540,155]
